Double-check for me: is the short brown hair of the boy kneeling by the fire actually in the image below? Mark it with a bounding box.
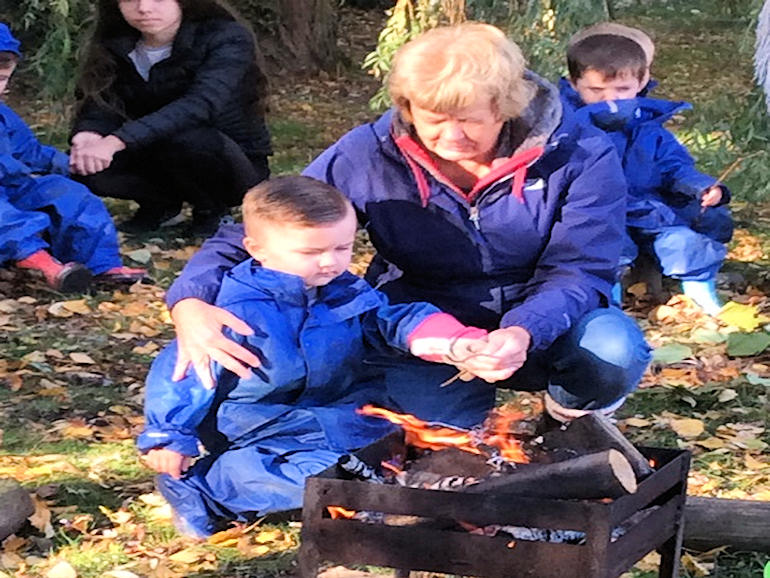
[243,175,352,235]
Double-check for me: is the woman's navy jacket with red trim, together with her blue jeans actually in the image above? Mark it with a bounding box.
[167,73,650,427]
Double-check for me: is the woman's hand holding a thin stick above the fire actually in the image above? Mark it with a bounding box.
[458,326,532,383]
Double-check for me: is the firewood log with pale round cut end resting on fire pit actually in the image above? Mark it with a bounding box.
[462,450,636,500]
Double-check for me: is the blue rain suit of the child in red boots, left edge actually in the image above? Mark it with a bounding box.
[0,104,122,275]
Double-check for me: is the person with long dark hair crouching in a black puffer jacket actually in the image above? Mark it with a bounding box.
[70,0,271,234]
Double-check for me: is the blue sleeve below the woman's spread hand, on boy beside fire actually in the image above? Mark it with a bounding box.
[136,342,215,457]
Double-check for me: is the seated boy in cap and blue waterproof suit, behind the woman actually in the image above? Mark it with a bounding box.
[560,23,733,315]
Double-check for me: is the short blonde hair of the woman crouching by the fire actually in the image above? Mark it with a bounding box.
[388,22,533,120]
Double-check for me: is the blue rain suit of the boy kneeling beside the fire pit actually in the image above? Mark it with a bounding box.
[138,260,439,536]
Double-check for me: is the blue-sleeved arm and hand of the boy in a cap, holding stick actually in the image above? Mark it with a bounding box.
[655,130,731,205]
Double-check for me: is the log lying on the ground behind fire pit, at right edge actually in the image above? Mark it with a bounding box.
[684,496,770,552]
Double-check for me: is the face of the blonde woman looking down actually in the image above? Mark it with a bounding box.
[409,98,503,163]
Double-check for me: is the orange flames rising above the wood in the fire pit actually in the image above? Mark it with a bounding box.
[358,405,529,463]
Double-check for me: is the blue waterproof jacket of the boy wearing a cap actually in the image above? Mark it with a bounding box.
[560,79,732,243]
